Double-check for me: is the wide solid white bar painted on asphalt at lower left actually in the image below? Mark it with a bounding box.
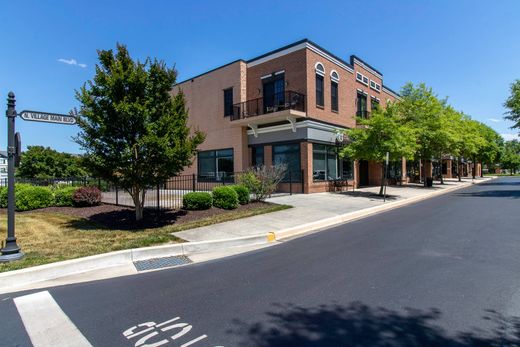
[14,291,92,347]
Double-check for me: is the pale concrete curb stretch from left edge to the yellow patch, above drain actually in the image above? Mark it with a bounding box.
[0,234,269,292]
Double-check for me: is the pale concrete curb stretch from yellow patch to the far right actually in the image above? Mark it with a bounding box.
[271,177,495,241]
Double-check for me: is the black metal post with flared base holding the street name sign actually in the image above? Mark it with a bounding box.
[0,92,24,262]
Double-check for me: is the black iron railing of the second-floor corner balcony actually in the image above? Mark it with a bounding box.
[231,90,305,121]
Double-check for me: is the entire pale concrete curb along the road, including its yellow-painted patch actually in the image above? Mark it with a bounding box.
[0,178,492,293]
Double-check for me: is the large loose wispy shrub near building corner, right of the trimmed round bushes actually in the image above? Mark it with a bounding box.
[238,164,287,201]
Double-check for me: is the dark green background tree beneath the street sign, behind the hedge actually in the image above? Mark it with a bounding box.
[16,146,89,178]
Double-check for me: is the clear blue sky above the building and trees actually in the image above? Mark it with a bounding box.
[0,0,520,153]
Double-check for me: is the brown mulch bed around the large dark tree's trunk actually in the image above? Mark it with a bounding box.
[1,202,271,230]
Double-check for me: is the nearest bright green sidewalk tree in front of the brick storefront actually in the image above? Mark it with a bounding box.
[340,104,417,195]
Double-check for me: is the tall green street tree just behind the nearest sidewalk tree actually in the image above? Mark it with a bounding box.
[398,83,448,185]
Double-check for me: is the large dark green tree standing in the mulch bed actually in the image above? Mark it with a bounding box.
[75,44,204,220]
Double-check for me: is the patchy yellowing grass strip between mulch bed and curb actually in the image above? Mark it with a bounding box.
[0,205,291,272]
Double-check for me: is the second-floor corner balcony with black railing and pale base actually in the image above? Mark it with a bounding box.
[230,91,307,126]
